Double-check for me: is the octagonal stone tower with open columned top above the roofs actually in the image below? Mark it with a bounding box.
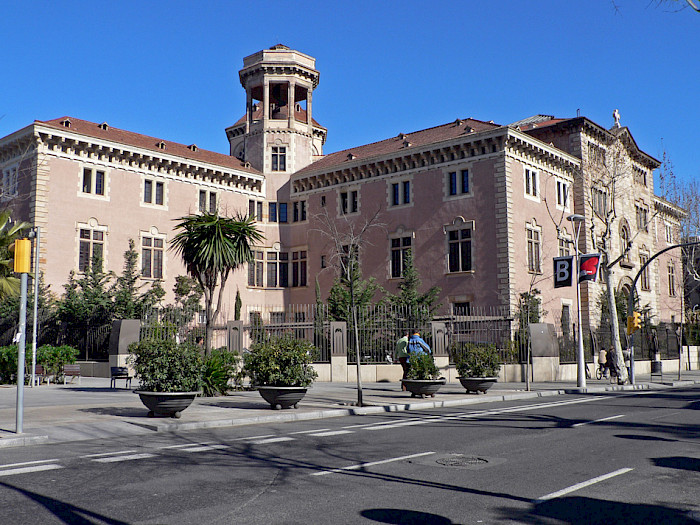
[226,44,327,175]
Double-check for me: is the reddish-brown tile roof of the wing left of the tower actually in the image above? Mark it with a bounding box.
[35,117,261,175]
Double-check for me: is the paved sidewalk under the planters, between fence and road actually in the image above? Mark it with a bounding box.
[0,370,700,448]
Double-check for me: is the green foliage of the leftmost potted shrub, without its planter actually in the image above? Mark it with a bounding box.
[129,339,204,392]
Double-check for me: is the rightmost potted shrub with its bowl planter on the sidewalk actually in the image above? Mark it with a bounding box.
[452,344,501,394]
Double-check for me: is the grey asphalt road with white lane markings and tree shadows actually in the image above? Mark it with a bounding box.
[0,387,700,525]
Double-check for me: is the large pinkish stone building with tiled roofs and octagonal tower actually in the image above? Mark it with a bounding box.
[0,45,682,329]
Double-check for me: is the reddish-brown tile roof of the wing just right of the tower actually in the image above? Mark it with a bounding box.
[297,118,501,174]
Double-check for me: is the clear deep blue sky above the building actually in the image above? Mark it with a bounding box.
[0,0,700,188]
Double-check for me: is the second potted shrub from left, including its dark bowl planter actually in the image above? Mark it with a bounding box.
[243,337,318,410]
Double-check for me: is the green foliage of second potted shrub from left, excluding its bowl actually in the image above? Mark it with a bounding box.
[243,337,318,387]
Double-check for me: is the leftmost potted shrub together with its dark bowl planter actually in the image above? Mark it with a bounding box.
[129,339,203,418]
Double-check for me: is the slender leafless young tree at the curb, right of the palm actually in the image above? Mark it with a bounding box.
[313,208,385,406]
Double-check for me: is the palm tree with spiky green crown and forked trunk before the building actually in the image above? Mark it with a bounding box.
[170,212,264,355]
